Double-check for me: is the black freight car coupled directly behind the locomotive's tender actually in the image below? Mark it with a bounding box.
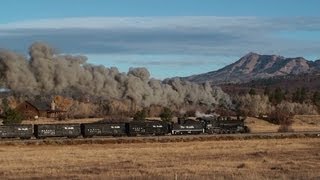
[126,120,169,136]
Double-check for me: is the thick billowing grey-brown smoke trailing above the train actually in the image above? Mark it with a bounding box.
[0,43,229,107]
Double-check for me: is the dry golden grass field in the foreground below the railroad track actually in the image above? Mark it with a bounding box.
[0,138,320,179]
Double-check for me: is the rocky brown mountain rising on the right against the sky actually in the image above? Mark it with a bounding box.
[182,52,320,84]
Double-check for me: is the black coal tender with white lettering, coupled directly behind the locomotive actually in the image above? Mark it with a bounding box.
[171,119,205,135]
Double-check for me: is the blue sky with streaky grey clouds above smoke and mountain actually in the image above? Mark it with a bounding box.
[0,0,320,79]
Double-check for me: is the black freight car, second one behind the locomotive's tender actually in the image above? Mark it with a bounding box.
[81,123,126,137]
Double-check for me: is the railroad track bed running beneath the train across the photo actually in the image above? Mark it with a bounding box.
[0,131,320,145]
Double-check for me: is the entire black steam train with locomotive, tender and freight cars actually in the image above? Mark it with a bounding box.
[0,117,250,139]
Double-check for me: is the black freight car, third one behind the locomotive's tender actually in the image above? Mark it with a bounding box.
[34,124,81,138]
